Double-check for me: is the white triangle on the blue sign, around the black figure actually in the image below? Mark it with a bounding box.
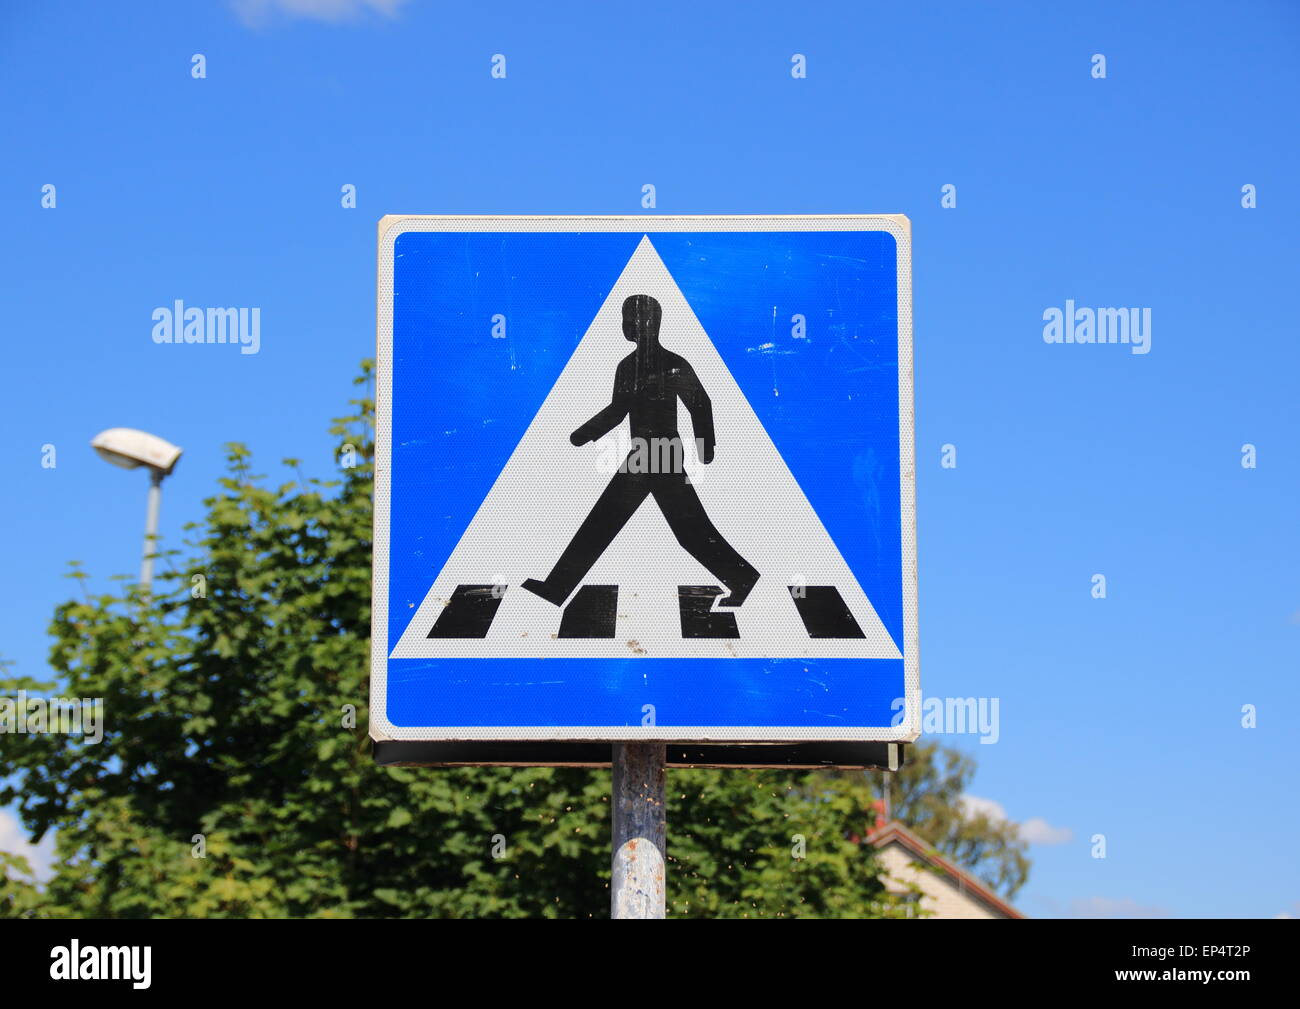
[391,237,901,659]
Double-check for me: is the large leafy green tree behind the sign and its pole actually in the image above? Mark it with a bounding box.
[0,363,1029,917]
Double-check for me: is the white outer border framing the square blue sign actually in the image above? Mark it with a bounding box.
[369,213,920,742]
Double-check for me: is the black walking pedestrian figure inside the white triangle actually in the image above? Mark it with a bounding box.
[524,294,758,606]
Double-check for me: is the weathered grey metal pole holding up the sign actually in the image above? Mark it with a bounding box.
[610,742,667,918]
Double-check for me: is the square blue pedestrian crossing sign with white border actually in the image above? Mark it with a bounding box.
[371,215,920,742]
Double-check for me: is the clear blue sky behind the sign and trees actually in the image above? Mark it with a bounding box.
[0,0,1300,917]
